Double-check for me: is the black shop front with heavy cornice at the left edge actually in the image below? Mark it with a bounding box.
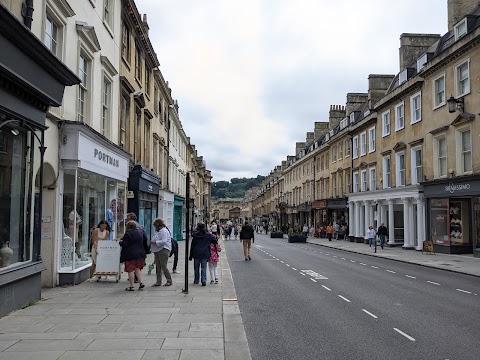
[0,2,79,316]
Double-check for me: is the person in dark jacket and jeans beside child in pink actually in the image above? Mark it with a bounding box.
[188,223,216,286]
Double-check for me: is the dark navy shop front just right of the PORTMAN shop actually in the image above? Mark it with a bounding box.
[128,165,160,242]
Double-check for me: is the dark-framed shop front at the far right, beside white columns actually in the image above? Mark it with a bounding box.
[423,175,480,257]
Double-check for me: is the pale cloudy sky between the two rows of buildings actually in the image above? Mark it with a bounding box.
[136,0,447,181]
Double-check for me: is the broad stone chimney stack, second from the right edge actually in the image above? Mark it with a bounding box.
[400,34,440,72]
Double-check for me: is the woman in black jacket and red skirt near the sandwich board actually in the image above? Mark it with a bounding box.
[119,220,148,291]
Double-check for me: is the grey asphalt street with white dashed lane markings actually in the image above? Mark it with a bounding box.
[225,234,480,360]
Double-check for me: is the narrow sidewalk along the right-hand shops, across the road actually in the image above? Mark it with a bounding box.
[307,237,480,276]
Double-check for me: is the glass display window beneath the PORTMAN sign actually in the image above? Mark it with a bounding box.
[60,169,126,271]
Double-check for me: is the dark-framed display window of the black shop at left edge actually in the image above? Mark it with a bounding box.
[0,126,40,269]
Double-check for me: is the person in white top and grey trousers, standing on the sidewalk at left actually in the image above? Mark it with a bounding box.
[150,218,173,286]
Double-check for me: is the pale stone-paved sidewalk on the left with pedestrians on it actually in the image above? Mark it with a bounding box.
[0,242,251,360]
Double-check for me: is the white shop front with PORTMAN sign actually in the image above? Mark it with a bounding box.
[57,121,130,286]
